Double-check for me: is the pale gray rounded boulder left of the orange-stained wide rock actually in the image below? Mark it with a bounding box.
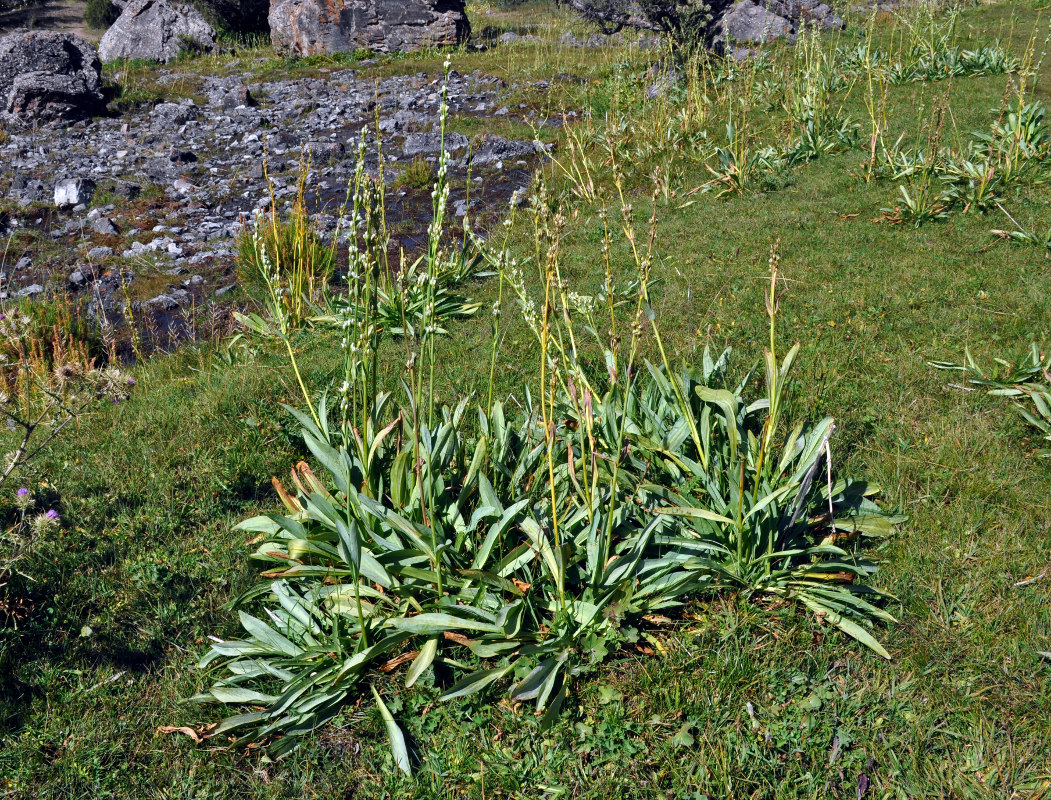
[99,0,215,64]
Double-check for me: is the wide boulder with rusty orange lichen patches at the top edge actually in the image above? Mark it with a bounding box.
[270,0,471,56]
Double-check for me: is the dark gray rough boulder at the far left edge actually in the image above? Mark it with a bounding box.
[0,30,104,124]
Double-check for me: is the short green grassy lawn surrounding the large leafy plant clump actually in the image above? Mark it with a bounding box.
[0,3,1051,799]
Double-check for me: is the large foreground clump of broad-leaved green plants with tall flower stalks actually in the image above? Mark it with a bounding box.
[189,72,902,772]
